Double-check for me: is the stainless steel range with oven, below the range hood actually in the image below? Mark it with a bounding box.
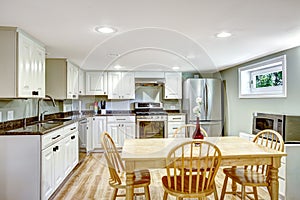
[134,102,168,138]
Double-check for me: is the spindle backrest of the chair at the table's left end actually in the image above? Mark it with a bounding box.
[101,132,124,184]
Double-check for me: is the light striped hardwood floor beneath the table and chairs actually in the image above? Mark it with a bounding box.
[51,153,270,200]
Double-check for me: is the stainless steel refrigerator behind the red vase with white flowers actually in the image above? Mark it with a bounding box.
[183,78,224,137]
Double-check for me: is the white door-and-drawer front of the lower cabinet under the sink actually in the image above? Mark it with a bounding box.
[41,123,79,199]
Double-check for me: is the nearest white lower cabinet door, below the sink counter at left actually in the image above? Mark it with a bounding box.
[41,146,54,200]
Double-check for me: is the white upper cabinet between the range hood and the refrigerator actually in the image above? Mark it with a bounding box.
[164,72,182,99]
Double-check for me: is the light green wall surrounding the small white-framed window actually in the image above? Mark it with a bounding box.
[221,47,300,135]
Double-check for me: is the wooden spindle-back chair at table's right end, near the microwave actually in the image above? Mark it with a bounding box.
[221,130,284,200]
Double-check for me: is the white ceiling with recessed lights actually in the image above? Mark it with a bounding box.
[0,0,300,72]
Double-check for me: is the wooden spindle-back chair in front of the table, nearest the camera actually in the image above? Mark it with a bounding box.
[162,140,221,200]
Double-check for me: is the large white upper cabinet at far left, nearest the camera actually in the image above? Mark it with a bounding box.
[0,27,45,98]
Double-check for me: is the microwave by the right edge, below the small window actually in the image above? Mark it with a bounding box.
[252,113,300,144]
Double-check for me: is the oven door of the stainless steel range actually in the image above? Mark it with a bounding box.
[136,119,167,138]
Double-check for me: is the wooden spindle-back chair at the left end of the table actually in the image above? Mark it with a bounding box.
[101,132,151,200]
